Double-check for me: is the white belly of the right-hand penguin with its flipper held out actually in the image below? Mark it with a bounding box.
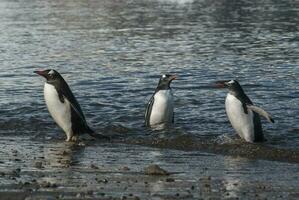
[225,94,254,142]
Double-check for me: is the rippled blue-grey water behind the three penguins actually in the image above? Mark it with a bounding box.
[0,0,299,150]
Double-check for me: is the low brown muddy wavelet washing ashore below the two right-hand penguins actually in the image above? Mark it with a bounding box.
[124,136,299,163]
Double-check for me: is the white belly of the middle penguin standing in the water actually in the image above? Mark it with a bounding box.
[150,90,173,125]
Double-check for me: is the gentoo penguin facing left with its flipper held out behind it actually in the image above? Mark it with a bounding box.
[217,80,274,143]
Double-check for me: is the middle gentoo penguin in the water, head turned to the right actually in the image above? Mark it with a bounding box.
[145,74,177,126]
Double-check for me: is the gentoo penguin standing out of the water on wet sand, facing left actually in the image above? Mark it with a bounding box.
[34,69,108,141]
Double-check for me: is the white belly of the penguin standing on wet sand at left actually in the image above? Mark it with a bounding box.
[44,83,72,140]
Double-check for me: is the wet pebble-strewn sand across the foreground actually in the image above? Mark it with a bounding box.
[0,137,299,200]
